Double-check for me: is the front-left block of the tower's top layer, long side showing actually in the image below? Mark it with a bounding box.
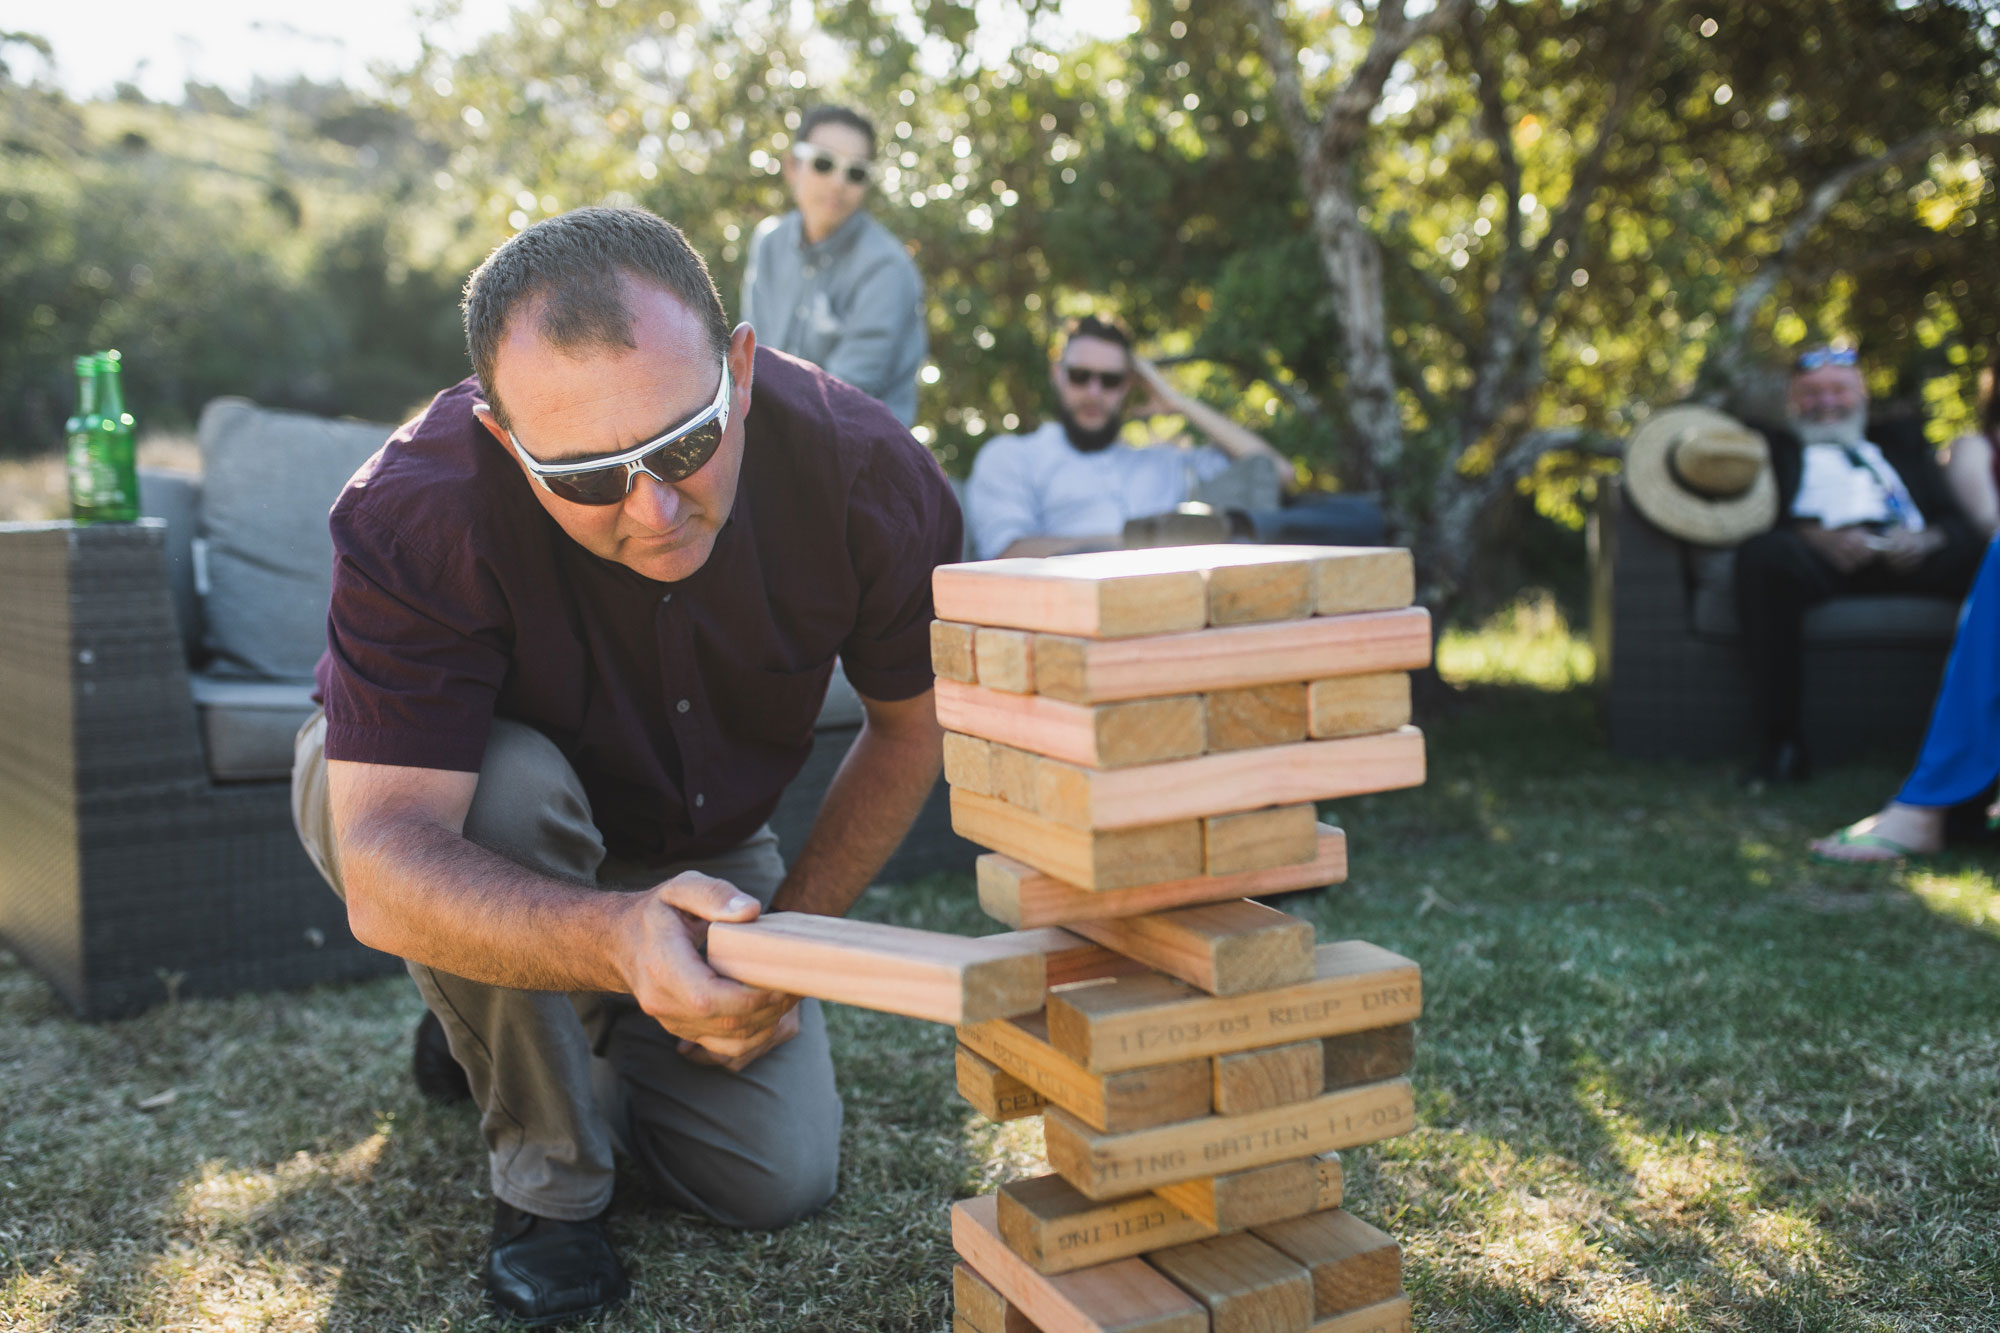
[930,550,1208,638]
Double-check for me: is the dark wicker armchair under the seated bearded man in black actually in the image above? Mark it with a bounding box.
[1590,482,1958,763]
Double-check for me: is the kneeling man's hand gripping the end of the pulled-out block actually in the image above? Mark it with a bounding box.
[624,871,798,1069]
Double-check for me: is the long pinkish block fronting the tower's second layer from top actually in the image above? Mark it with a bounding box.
[1034,606,1430,705]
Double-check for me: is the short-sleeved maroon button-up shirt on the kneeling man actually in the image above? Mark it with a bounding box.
[318,348,960,861]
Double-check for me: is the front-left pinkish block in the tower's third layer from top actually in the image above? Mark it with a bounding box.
[938,680,1206,769]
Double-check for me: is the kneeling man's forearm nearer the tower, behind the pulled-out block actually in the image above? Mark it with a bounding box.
[770,695,944,917]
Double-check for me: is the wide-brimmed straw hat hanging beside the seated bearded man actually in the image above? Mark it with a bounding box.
[1624,406,1778,546]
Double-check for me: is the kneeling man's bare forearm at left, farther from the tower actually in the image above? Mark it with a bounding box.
[340,819,628,991]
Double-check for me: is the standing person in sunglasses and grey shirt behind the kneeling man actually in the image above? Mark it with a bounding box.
[742,106,930,426]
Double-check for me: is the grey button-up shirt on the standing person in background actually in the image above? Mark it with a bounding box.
[742,210,930,426]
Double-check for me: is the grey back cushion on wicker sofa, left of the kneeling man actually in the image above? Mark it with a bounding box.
[200,398,394,681]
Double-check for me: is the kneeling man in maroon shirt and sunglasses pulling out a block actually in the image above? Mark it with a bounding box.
[294,208,960,1323]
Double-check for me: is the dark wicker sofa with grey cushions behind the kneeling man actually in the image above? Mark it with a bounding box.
[0,398,974,1019]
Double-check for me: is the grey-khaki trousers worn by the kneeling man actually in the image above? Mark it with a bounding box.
[292,713,842,1229]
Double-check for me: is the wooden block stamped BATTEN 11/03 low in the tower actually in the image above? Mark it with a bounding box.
[1042,1079,1416,1203]
